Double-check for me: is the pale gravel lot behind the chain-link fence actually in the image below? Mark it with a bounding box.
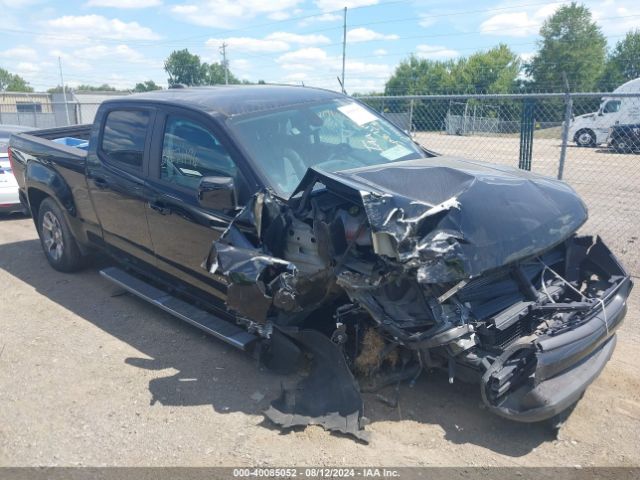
[416,130,640,275]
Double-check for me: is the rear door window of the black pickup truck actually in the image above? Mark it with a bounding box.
[100,110,150,169]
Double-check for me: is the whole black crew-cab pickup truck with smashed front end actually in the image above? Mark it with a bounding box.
[10,86,632,438]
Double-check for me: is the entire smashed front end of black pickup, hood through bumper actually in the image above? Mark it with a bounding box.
[206,159,632,440]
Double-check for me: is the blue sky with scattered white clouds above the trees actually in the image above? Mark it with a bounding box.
[0,0,640,93]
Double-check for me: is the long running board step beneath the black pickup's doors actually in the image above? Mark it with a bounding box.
[100,267,258,350]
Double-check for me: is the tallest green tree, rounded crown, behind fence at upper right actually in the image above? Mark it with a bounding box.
[526,3,607,91]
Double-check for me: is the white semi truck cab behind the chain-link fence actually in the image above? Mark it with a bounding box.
[569,78,640,147]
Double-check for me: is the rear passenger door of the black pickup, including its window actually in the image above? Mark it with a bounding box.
[87,104,156,265]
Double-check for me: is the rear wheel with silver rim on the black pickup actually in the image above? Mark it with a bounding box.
[38,198,83,273]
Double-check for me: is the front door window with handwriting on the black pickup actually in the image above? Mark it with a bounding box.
[160,116,236,189]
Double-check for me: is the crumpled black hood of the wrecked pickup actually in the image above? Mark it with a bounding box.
[294,156,587,283]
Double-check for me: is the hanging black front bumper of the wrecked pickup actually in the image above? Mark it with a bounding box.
[481,240,633,422]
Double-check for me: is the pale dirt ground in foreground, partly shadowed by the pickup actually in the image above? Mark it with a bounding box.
[0,217,640,466]
